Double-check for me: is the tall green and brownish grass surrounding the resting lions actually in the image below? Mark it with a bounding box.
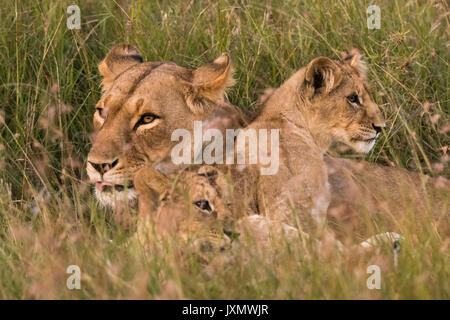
[0,0,450,299]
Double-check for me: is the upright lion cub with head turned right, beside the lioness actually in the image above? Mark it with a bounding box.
[232,52,385,228]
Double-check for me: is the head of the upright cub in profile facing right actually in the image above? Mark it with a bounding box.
[297,52,385,153]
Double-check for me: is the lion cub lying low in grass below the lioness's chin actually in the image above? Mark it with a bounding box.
[134,165,300,251]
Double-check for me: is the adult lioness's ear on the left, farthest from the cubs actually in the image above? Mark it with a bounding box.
[98,44,142,90]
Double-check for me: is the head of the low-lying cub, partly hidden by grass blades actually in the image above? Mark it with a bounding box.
[134,166,233,249]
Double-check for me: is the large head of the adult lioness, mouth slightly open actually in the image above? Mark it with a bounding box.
[87,45,242,206]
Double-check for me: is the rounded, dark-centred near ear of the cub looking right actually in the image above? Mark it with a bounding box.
[305,57,342,93]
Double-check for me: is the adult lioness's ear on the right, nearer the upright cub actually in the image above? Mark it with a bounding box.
[187,53,235,113]
